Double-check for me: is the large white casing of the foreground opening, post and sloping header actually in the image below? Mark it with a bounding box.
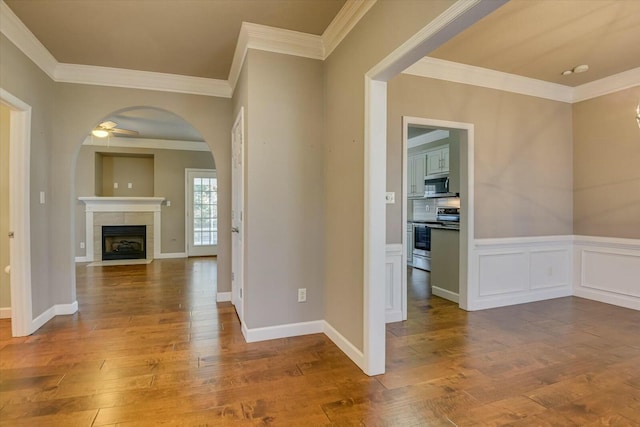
[361,0,508,375]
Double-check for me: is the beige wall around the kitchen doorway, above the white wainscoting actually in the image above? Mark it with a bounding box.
[387,74,573,243]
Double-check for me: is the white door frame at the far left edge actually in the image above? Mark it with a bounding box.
[0,88,34,337]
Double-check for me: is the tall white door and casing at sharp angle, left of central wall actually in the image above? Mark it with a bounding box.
[231,107,244,323]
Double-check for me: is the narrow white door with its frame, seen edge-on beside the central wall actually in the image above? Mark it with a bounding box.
[231,107,246,324]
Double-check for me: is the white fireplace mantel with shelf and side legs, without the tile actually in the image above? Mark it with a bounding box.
[78,196,165,261]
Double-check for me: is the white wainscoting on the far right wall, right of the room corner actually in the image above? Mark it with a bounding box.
[574,236,640,310]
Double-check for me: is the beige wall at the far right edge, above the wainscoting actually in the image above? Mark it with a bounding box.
[573,86,640,239]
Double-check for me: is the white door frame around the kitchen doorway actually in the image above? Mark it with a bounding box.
[401,116,474,320]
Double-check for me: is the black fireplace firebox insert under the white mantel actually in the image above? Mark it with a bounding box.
[102,225,147,260]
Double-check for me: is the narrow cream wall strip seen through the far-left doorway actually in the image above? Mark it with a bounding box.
[0,104,11,308]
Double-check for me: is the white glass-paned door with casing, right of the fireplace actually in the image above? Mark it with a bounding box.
[185,168,218,256]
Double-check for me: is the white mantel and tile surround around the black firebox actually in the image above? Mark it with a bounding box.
[78,197,164,261]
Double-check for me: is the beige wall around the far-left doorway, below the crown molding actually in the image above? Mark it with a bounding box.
[0,34,54,318]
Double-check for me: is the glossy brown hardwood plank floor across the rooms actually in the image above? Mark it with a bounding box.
[0,258,640,426]
